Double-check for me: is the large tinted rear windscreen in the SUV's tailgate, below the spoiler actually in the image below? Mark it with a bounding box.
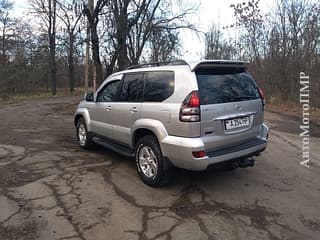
[196,68,260,105]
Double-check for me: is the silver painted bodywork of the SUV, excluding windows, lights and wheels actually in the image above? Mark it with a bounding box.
[75,61,269,170]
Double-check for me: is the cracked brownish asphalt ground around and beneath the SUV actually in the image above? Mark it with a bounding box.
[0,97,320,240]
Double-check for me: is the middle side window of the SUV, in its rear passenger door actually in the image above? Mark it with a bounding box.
[119,72,144,102]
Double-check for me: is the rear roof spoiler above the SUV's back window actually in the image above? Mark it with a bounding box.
[189,60,249,71]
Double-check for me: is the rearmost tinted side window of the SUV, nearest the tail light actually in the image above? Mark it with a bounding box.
[143,71,174,102]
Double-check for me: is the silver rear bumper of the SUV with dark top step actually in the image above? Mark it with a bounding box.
[160,124,269,171]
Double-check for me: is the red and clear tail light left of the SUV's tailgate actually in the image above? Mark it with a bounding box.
[179,91,200,122]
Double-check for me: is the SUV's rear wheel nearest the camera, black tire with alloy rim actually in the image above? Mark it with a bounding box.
[135,135,172,187]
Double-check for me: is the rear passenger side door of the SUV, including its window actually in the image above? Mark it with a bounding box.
[112,72,144,146]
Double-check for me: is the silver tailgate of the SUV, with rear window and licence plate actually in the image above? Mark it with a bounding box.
[196,67,263,150]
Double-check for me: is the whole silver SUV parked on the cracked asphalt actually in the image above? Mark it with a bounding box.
[74,60,269,186]
